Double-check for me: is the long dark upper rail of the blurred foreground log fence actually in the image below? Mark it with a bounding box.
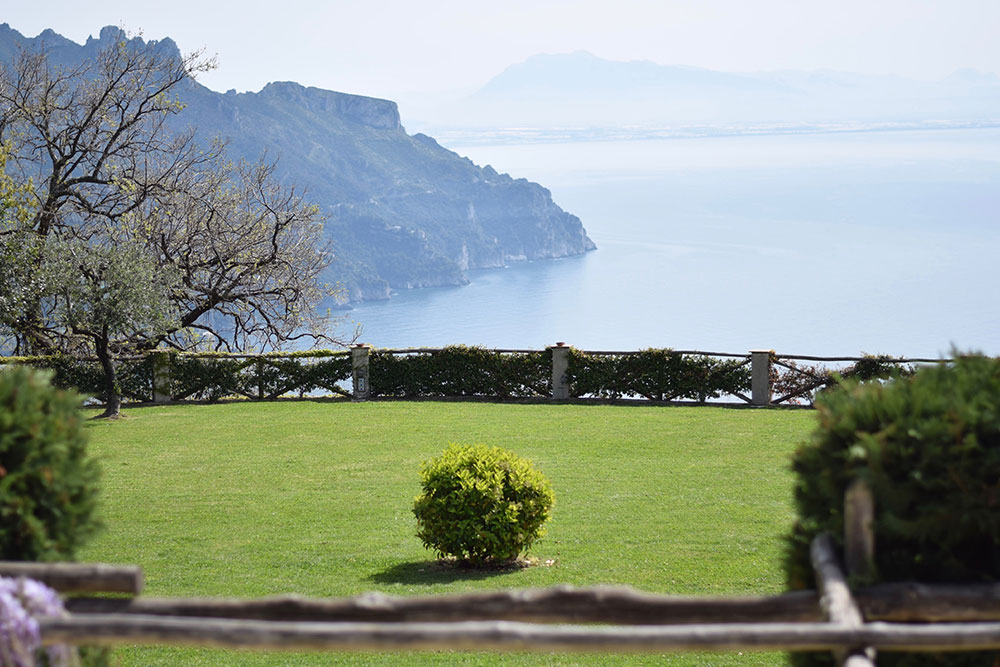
[54,583,1000,625]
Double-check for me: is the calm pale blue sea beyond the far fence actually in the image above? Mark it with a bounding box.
[340,129,1000,356]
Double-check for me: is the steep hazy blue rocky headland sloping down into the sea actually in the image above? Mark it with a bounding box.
[0,24,595,300]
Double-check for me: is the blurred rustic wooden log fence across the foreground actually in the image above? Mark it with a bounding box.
[0,483,1000,667]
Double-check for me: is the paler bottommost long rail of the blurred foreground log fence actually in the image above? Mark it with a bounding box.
[39,614,1000,653]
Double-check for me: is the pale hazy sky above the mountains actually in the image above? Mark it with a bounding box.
[0,0,1000,97]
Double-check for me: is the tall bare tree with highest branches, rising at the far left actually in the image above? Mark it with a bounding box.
[0,32,212,352]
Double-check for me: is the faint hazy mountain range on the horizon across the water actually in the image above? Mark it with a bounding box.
[406,51,1000,128]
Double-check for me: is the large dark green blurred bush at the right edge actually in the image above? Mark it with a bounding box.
[786,356,1000,665]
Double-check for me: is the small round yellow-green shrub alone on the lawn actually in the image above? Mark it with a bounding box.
[413,445,555,566]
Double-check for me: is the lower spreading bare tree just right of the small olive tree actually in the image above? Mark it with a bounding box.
[130,157,345,351]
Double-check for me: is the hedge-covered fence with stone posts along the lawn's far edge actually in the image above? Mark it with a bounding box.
[0,350,948,406]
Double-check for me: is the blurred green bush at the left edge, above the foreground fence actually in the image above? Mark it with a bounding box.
[0,367,98,561]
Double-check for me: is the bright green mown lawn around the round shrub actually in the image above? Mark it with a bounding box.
[79,402,814,665]
